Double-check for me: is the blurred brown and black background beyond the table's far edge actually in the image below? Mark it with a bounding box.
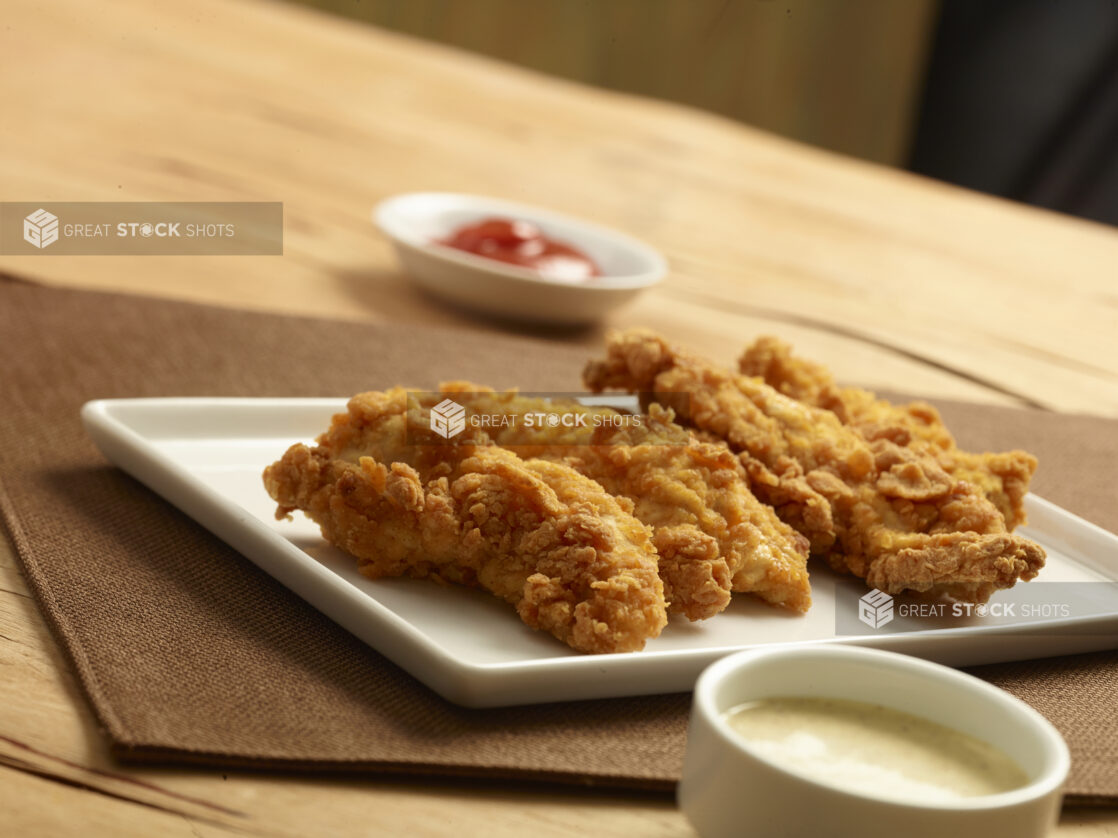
[301,0,1118,225]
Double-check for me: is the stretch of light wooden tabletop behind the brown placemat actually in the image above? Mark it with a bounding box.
[0,0,1118,415]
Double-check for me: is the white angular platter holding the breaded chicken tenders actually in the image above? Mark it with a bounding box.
[82,399,1118,707]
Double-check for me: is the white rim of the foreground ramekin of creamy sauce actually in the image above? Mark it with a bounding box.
[692,644,1071,812]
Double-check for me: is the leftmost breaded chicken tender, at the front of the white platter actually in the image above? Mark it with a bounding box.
[264,389,667,653]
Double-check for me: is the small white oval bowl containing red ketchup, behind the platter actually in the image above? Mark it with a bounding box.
[372,192,667,324]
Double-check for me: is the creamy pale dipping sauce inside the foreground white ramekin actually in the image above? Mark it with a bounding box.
[724,697,1029,802]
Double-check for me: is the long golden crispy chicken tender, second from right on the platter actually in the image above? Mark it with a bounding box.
[584,330,1044,602]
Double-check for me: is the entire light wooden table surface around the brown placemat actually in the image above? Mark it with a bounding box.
[0,0,1118,838]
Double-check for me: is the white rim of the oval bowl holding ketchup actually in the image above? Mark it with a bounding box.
[371,192,669,293]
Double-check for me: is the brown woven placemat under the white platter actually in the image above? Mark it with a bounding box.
[0,278,1118,799]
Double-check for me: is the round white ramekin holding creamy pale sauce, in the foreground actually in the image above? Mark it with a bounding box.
[679,646,1071,838]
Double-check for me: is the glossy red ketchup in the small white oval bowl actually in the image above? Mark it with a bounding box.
[438,218,601,282]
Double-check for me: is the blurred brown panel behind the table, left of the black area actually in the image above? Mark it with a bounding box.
[301,0,937,165]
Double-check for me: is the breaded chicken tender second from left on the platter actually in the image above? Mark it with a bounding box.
[429,381,811,620]
